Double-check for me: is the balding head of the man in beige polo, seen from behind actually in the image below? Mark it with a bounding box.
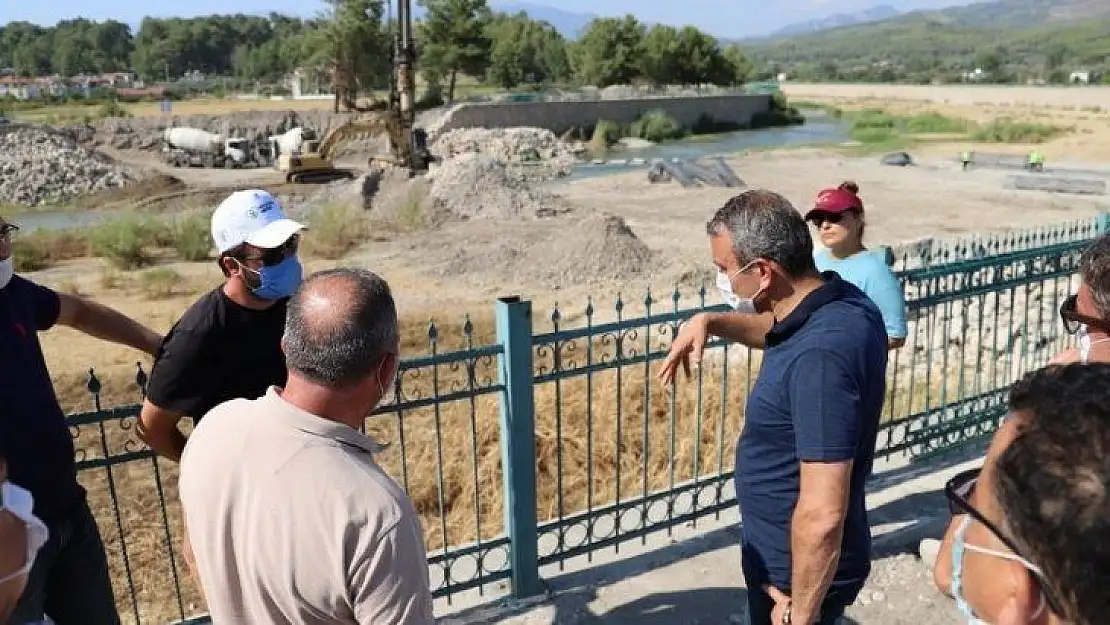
[285,268,398,389]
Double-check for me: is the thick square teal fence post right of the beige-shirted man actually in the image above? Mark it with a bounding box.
[497,296,543,598]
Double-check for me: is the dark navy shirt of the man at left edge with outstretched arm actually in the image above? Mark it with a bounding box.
[0,275,84,523]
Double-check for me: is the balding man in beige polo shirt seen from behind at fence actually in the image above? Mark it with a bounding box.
[180,269,434,625]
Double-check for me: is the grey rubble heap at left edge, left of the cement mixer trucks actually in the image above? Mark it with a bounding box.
[0,127,132,206]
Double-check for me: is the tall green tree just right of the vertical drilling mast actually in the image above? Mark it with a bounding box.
[416,0,492,101]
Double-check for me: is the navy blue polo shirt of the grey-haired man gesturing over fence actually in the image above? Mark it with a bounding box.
[736,272,887,604]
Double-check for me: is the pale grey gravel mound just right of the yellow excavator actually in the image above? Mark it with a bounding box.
[427,152,568,220]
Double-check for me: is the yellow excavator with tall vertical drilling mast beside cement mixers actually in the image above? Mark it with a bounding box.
[275,0,435,183]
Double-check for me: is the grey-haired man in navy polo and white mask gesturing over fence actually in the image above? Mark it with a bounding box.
[670,190,887,625]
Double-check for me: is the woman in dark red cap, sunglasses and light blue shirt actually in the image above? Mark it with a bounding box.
[806,182,907,349]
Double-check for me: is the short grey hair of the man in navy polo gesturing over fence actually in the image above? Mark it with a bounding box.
[706,189,816,278]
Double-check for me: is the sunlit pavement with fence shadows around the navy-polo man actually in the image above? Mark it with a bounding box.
[438,452,978,625]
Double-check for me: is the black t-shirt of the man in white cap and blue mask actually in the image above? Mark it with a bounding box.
[147,286,287,423]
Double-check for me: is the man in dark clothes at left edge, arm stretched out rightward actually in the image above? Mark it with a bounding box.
[0,219,161,625]
